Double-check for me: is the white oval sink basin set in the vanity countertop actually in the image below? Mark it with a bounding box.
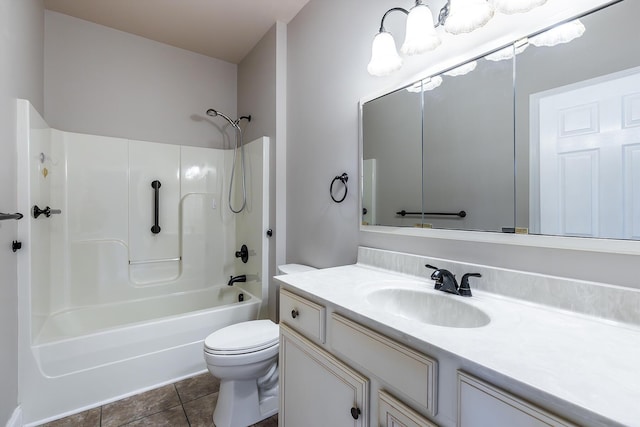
[366,288,491,328]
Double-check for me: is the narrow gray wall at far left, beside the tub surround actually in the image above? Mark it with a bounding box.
[0,0,44,425]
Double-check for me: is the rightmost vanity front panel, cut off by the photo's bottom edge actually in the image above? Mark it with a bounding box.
[458,372,576,427]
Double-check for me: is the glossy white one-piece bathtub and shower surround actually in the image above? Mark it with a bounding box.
[18,101,269,425]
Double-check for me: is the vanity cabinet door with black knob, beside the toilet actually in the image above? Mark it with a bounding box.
[278,324,369,427]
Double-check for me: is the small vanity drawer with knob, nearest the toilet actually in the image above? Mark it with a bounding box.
[280,289,326,343]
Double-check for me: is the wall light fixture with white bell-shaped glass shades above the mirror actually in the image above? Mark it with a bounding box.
[367,0,547,76]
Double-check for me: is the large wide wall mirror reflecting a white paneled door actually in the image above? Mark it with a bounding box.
[362,0,640,240]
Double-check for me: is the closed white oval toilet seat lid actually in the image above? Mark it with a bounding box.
[204,320,280,352]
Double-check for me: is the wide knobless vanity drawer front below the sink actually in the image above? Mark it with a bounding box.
[331,313,438,415]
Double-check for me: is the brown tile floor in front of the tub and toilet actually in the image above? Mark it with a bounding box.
[42,372,278,427]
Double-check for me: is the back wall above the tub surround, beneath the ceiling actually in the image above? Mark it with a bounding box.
[45,11,237,148]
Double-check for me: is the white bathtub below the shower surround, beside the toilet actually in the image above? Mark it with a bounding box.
[23,285,261,425]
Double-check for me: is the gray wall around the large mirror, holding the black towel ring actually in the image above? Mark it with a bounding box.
[287,0,638,287]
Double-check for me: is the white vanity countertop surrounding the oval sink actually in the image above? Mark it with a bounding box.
[277,264,640,426]
